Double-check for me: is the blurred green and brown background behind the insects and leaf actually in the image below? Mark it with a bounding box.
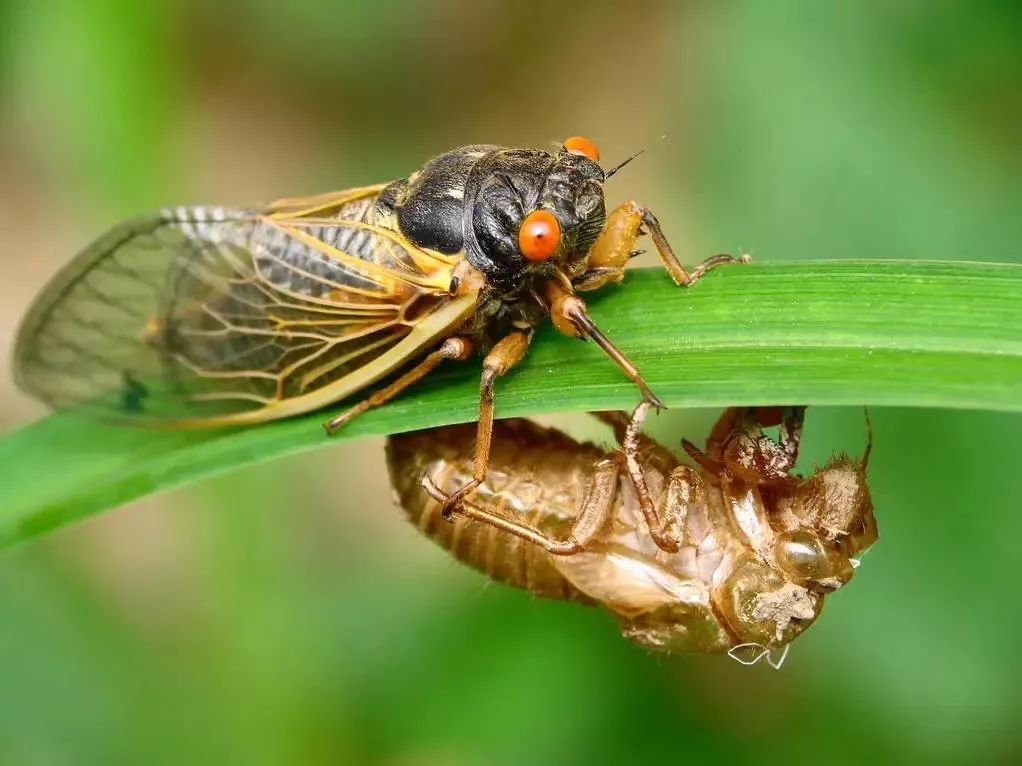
[0,0,1022,766]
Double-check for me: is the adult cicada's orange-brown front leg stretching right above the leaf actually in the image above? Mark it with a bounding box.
[577,202,752,290]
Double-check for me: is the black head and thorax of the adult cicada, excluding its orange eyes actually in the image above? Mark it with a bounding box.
[372,144,606,350]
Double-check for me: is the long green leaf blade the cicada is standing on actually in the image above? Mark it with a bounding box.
[0,260,1022,545]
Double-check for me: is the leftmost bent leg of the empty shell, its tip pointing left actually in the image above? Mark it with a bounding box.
[422,460,619,556]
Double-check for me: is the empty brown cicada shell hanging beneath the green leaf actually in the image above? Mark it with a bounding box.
[387,403,877,666]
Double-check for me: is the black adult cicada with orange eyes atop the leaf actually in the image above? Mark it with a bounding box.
[14,137,733,512]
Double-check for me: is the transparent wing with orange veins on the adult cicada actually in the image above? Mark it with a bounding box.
[14,187,463,425]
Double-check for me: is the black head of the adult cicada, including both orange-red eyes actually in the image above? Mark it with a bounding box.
[465,138,606,291]
